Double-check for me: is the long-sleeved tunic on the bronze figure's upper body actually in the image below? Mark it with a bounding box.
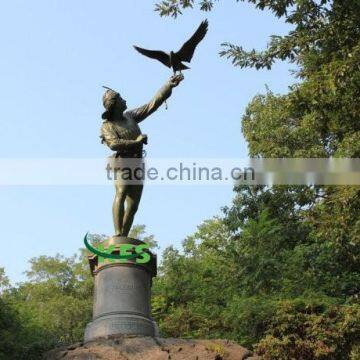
[100,82,172,158]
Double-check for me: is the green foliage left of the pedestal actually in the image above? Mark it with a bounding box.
[0,255,93,360]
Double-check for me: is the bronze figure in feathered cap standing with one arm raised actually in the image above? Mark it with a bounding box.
[100,75,184,237]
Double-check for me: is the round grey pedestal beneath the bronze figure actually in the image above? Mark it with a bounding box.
[85,237,158,341]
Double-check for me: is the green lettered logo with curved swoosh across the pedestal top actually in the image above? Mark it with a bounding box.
[84,233,151,264]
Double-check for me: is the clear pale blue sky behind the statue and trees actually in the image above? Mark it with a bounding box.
[0,0,294,284]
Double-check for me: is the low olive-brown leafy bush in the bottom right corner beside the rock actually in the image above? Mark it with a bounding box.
[257,300,360,360]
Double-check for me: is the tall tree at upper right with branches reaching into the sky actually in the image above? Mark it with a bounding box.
[156,0,360,297]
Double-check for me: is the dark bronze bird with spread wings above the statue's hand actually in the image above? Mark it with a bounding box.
[134,20,208,74]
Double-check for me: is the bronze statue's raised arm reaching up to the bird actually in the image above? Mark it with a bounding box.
[125,74,184,123]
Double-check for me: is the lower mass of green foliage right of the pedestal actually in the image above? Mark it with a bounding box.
[153,210,360,359]
